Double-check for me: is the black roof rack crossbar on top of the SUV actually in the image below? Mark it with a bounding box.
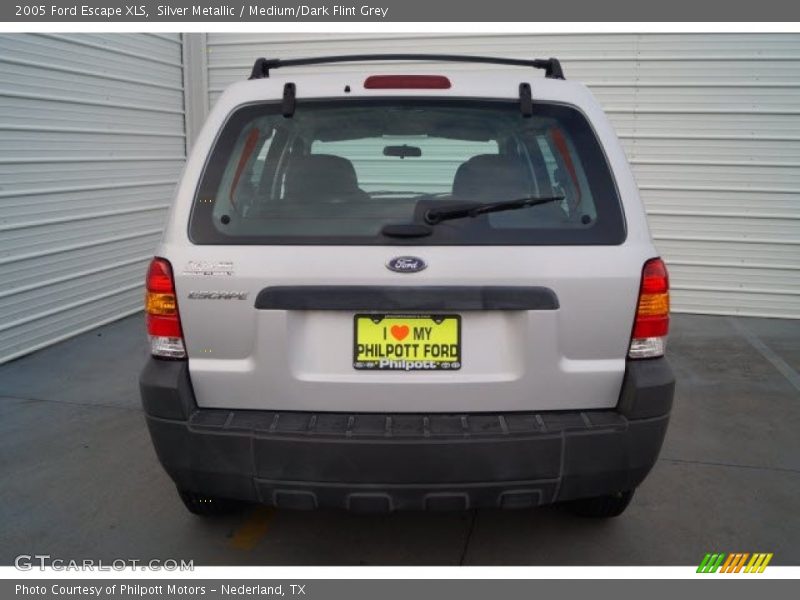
[250,54,564,79]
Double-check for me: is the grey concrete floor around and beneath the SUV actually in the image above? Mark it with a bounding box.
[0,315,800,565]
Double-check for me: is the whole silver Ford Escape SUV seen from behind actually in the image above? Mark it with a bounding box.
[141,55,674,516]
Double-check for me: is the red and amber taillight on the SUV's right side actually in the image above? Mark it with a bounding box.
[628,258,669,358]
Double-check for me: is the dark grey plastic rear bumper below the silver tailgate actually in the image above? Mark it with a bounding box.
[140,359,674,512]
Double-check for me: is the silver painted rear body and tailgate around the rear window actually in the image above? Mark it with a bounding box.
[158,70,656,412]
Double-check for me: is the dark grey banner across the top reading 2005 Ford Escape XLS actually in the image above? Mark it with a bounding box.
[0,0,800,23]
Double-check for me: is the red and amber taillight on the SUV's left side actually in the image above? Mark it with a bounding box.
[144,258,186,358]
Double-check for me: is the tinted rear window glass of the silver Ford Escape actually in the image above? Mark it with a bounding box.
[189,99,625,245]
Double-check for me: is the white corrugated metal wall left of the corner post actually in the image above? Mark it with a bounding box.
[0,34,186,362]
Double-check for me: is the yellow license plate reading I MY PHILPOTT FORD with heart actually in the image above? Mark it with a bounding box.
[353,315,461,371]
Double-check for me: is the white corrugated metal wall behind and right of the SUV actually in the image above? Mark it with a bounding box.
[207,34,800,318]
